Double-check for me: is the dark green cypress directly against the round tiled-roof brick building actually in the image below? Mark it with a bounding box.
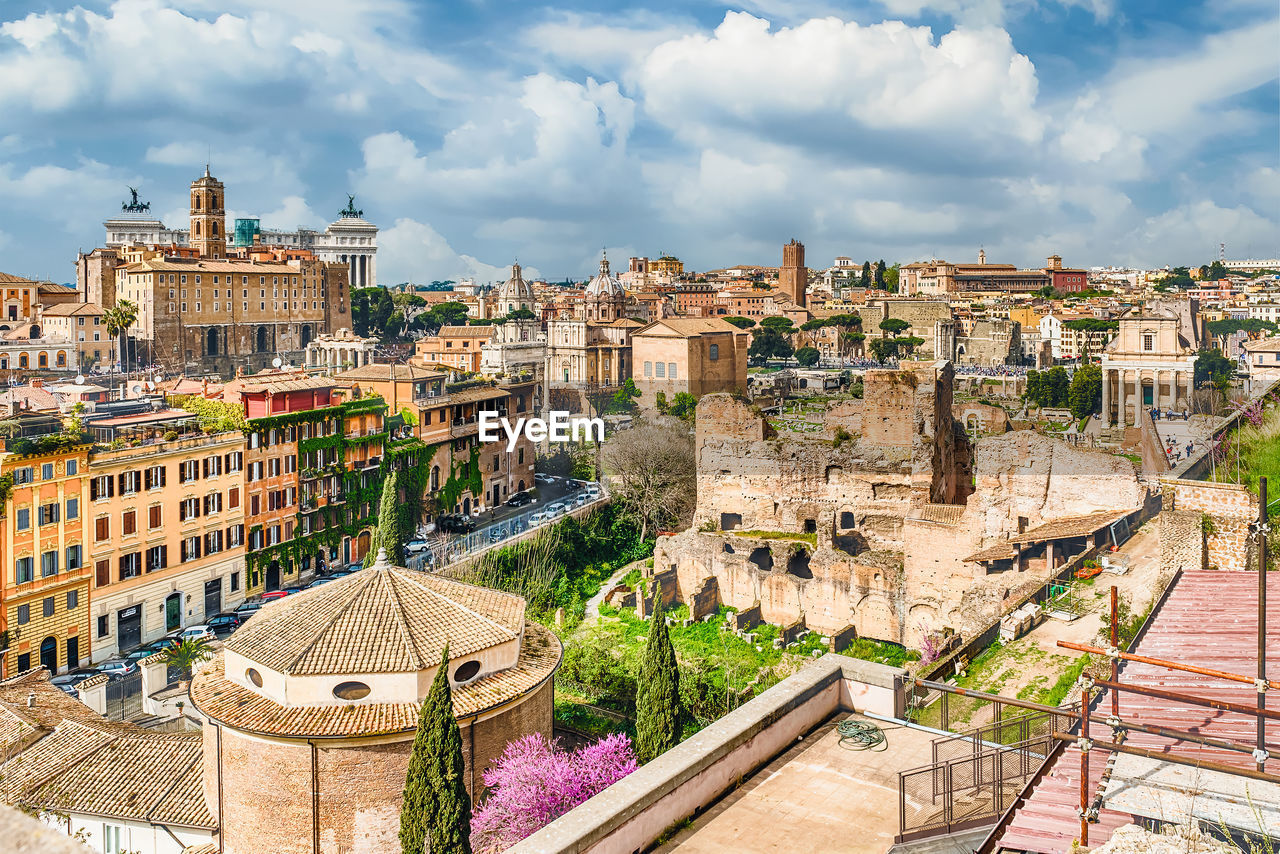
[399,645,471,854]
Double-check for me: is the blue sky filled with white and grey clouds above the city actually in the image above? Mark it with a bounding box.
[0,0,1280,284]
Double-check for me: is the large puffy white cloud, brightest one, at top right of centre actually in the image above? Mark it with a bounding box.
[639,13,1044,145]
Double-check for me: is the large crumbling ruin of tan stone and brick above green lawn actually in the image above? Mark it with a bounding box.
[654,362,1146,645]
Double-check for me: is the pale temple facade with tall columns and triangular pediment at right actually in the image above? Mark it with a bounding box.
[1102,303,1199,428]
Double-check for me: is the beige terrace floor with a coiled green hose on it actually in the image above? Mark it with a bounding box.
[655,713,936,854]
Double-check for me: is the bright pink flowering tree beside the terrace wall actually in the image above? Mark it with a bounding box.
[471,732,636,854]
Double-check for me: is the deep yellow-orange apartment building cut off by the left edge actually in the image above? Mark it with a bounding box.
[0,414,91,679]
